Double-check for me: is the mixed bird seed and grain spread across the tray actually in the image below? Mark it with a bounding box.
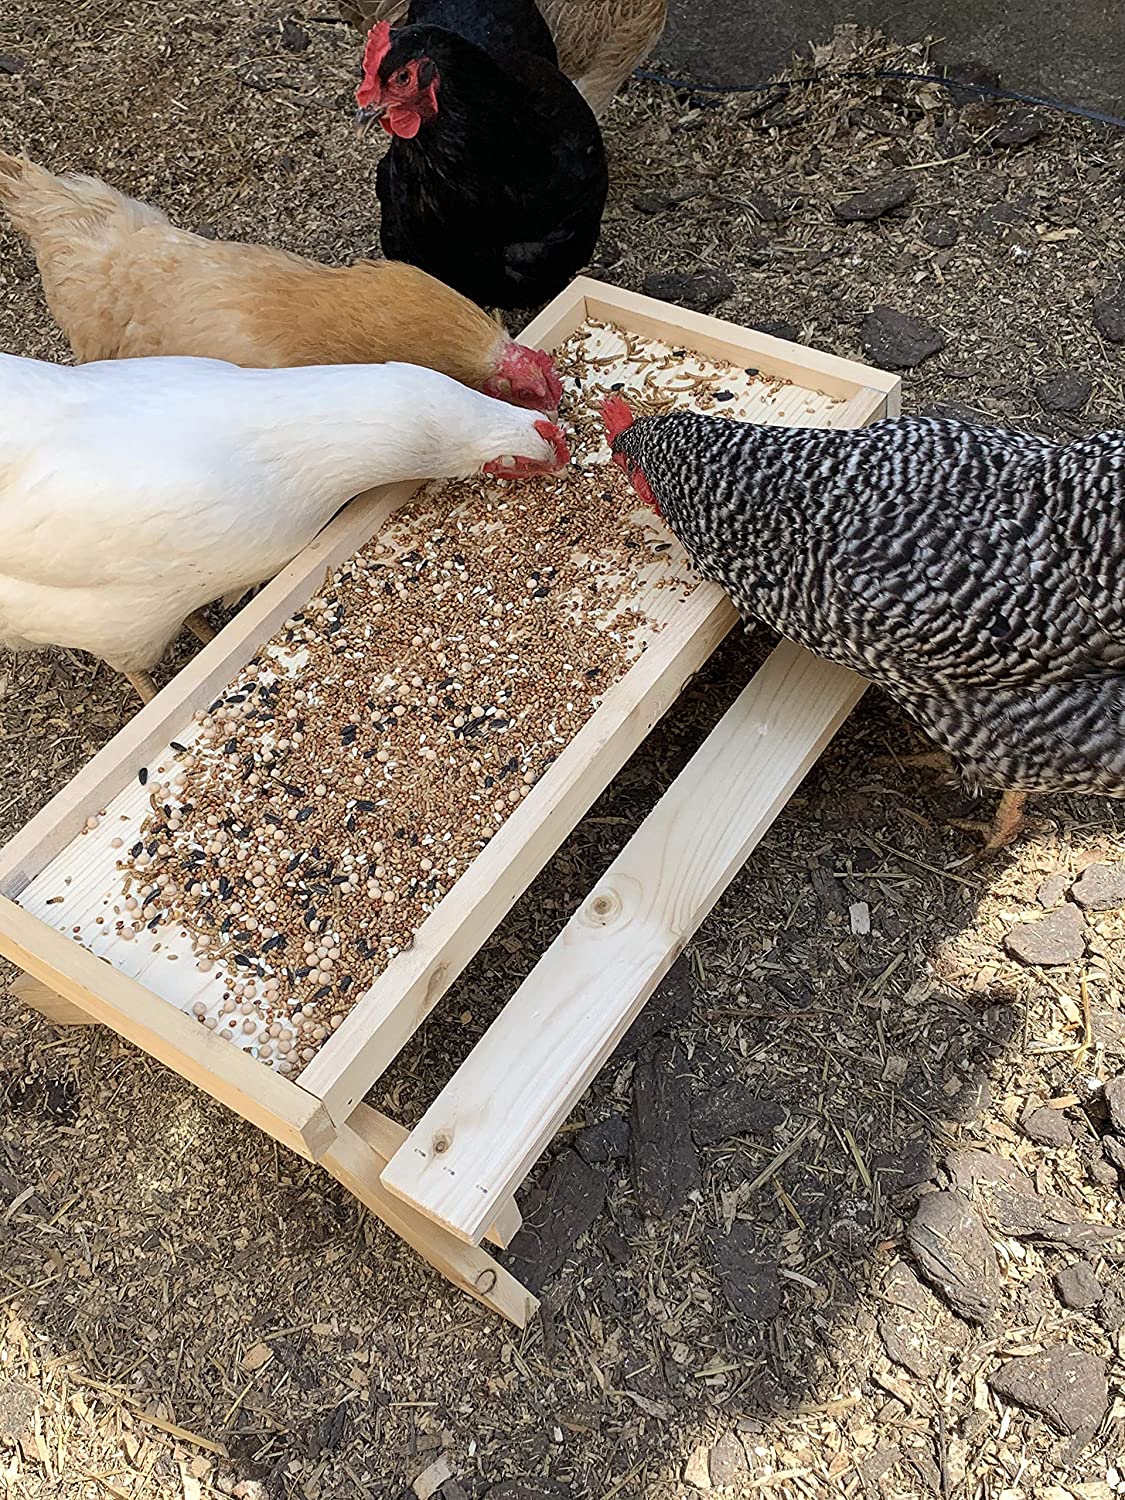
[30,324,812,1076]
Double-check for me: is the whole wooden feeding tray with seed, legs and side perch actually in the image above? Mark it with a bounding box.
[0,281,899,1325]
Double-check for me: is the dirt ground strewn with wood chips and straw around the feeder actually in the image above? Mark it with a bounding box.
[0,0,1125,1500]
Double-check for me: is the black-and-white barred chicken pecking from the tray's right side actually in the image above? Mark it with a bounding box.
[606,398,1125,848]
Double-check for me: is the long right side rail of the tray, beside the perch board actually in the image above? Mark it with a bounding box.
[302,584,737,1124]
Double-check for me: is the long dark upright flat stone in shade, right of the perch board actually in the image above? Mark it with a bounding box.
[629,1037,699,1217]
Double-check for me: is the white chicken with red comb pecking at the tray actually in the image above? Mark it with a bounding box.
[0,354,569,702]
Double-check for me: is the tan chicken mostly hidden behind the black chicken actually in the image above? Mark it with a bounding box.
[339,0,668,117]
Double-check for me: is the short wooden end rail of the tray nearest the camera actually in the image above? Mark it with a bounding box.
[0,897,335,1161]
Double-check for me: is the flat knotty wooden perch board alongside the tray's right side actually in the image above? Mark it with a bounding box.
[383,642,864,1242]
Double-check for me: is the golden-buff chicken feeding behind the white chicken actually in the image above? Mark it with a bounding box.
[0,152,561,413]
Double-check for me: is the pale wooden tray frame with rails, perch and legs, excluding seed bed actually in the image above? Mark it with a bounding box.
[0,278,900,1326]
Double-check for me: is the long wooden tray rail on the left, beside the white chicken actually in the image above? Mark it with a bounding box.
[0,483,417,897]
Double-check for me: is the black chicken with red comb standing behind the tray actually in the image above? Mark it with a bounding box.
[356,0,609,308]
